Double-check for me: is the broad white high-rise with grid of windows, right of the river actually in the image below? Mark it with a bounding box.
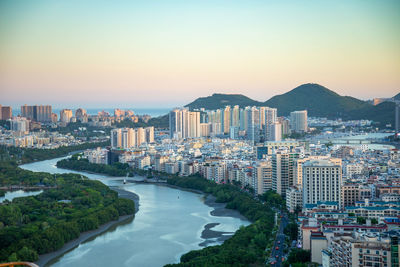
[303,159,342,206]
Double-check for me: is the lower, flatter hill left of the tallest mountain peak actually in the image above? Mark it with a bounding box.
[185,94,262,110]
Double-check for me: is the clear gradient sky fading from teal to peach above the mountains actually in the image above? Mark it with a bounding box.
[0,0,400,107]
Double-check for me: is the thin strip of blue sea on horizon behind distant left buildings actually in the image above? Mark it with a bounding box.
[13,108,172,117]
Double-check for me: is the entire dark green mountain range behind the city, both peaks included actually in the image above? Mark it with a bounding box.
[185,83,400,130]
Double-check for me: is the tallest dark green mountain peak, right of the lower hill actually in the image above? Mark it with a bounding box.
[264,83,371,119]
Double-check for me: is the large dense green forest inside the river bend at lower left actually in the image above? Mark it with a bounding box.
[0,161,135,262]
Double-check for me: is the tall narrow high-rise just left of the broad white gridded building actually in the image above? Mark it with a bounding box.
[272,153,298,196]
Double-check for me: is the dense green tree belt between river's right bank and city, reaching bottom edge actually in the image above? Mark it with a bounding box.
[162,176,283,266]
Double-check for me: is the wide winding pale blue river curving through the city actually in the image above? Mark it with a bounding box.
[20,158,250,267]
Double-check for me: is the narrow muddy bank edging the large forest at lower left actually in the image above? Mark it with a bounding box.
[35,187,139,266]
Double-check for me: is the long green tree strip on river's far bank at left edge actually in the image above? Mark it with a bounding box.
[0,141,110,164]
